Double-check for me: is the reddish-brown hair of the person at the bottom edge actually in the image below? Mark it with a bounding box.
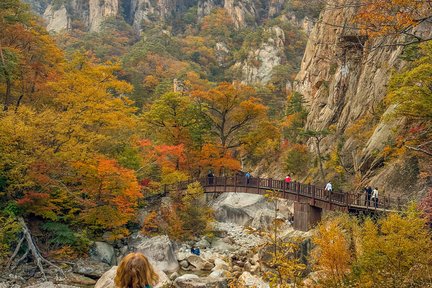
[114,253,159,288]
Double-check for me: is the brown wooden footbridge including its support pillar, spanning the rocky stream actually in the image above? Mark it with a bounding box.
[168,176,401,230]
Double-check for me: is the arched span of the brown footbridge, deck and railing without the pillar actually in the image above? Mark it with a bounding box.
[168,177,400,212]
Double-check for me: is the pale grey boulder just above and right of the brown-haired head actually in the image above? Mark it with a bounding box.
[129,234,179,273]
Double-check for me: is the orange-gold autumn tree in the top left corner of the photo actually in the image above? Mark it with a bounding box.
[0,0,62,110]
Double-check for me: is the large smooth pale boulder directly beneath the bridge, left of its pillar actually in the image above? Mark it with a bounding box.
[212,193,294,229]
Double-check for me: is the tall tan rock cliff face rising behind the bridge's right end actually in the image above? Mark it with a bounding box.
[295,0,431,197]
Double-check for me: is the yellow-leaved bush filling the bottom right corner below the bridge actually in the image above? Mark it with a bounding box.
[357,205,432,287]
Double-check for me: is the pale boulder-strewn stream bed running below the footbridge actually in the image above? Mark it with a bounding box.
[0,193,309,288]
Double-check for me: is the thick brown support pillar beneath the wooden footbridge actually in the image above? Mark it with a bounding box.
[293,202,322,231]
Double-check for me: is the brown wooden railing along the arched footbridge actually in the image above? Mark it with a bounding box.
[169,176,402,210]
